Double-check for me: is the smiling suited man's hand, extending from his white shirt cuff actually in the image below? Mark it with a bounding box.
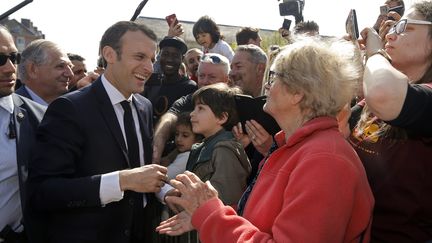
[119,164,168,192]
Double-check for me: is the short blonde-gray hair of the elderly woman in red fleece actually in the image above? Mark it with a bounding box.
[271,37,363,119]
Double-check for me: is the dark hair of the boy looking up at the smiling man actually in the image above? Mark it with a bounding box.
[192,83,241,130]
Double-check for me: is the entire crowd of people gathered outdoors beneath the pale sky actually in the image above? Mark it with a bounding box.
[0,0,432,243]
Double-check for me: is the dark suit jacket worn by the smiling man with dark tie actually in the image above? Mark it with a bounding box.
[29,78,154,243]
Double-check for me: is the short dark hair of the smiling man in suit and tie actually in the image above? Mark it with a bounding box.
[99,21,157,60]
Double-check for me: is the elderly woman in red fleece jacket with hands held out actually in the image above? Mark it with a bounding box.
[157,38,374,243]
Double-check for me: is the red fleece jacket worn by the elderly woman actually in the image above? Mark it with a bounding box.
[192,117,374,243]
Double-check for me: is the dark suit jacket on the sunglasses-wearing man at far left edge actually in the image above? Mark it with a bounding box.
[12,94,46,242]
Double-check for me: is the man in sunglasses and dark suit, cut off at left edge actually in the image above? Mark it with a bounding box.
[0,26,45,243]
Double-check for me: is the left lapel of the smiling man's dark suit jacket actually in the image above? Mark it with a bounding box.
[92,78,131,167]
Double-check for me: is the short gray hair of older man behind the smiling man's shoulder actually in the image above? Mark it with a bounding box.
[18,39,63,82]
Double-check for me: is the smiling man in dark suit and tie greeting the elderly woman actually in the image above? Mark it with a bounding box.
[28,21,171,243]
